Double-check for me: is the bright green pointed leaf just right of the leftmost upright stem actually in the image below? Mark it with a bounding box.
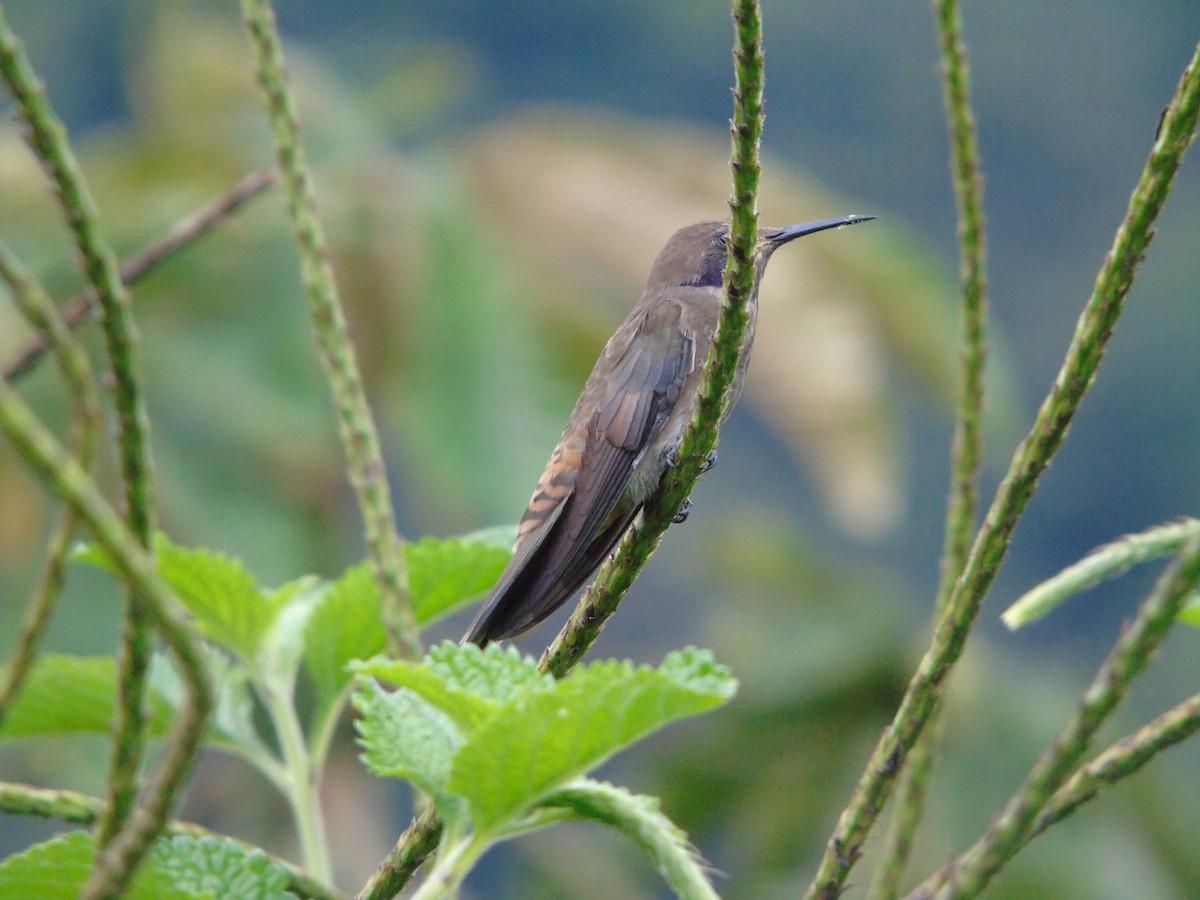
[155,535,278,664]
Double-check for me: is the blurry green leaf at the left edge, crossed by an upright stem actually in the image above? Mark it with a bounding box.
[0,653,172,744]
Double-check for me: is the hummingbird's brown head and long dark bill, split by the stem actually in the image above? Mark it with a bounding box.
[646,216,875,288]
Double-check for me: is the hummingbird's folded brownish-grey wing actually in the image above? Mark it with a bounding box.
[463,295,697,644]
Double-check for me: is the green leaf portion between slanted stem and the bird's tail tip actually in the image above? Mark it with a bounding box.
[404,528,515,625]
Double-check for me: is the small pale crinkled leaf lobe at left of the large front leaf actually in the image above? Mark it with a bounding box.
[354,678,463,797]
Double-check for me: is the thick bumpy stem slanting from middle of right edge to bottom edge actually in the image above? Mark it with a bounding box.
[912,535,1200,900]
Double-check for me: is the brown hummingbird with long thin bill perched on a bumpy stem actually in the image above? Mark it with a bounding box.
[462,216,875,647]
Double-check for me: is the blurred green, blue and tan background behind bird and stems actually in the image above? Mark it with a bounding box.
[0,0,1200,898]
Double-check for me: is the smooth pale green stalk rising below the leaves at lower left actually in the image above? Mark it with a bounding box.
[259,685,334,883]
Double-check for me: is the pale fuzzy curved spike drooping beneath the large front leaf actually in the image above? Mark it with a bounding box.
[542,778,718,900]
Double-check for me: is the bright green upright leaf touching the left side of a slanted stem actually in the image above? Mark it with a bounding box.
[305,563,388,707]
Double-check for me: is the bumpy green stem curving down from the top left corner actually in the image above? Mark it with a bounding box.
[0,7,152,881]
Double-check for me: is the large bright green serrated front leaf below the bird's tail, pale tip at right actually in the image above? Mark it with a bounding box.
[448,648,737,833]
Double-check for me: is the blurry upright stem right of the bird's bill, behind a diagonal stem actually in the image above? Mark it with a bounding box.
[868,0,988,900]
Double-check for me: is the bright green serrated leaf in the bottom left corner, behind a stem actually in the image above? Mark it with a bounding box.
[0,832,201,900]
